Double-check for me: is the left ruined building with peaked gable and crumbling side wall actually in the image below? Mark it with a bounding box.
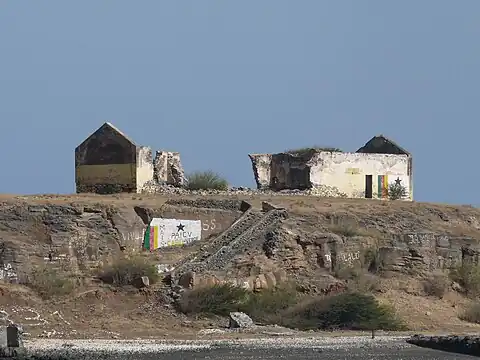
[75,122,185,194]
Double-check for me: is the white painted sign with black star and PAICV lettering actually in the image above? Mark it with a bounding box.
[143,218,202,250]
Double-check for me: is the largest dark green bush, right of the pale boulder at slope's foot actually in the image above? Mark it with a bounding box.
[283,292,405,330]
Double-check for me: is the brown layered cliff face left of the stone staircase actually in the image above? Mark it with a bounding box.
[0,196,242,282]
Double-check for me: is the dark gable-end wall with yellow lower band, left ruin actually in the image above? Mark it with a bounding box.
[75,125,137,193]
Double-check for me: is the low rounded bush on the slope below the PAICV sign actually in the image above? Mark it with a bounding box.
[98,255,159,286]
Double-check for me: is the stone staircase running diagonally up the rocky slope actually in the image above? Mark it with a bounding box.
[172,208,287,284]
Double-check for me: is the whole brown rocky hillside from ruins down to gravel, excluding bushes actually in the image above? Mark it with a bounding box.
[0,194,480,337]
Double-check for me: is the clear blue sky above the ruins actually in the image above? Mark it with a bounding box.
[0,0,480,204]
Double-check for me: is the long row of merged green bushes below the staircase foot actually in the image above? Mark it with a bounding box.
[178,285,403,330]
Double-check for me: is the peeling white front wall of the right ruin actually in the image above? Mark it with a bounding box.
[309,152,412,200]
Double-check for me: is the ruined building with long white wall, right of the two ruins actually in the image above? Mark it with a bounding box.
[249,135,413,200]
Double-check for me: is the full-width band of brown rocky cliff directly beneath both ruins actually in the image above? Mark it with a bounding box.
[0,196,480,288]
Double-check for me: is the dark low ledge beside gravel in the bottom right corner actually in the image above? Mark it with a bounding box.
[407,335,480,356]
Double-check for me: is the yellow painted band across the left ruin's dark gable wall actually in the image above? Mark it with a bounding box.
[75,164,137,185]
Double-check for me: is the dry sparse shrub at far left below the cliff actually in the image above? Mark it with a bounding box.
[20,266,75,300]
